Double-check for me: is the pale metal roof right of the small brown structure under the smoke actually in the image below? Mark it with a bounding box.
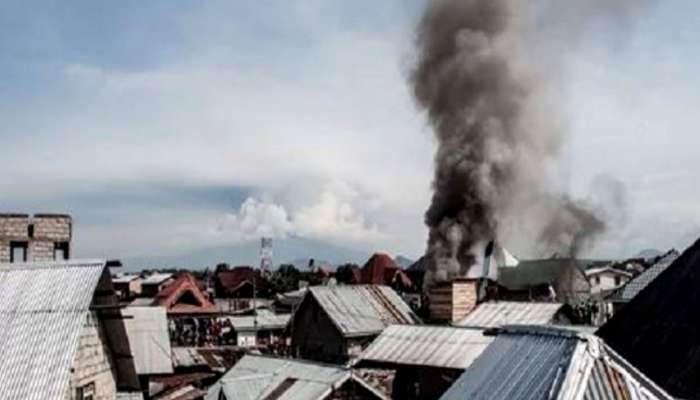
[455,301,564,328]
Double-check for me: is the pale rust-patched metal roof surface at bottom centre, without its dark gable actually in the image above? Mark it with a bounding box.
[207,355,350,400]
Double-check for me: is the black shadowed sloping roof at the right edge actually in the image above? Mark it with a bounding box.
[598,241,700,399]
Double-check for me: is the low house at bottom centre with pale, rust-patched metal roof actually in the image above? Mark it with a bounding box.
[207,355,386,400]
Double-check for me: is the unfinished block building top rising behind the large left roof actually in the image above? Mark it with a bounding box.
[0,214,73,263]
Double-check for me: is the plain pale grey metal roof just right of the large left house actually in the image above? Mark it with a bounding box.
[122,307,173,375]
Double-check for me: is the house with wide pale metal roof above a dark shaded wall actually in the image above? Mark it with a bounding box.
[353,325,493,400]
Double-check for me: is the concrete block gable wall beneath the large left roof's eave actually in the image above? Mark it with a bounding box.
[65,312,117,400]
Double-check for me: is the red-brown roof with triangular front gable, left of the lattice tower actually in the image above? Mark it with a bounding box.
[154,273,216,314]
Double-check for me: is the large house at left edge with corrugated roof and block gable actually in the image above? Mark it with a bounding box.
[0,260,141,400]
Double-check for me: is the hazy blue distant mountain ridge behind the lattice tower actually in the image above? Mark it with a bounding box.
[121,238,371,271]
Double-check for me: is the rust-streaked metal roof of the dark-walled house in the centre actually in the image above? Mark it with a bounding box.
[309,285,420,336]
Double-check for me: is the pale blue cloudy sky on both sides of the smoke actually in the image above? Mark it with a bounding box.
[0,0,700,257]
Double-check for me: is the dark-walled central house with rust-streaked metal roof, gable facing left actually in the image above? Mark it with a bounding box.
[289,285,420,362]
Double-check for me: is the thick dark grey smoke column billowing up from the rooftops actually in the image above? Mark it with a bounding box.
[410,0,641,281]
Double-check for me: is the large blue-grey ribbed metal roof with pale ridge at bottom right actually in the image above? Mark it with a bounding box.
[441,326,671,400]
